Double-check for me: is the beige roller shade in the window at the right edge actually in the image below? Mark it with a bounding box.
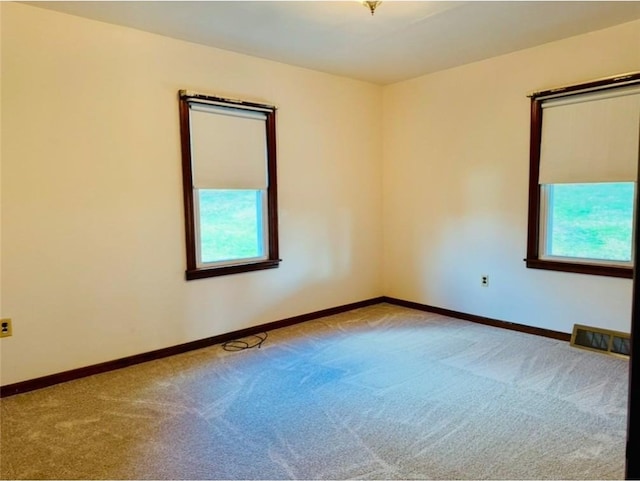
[539,86,640,184]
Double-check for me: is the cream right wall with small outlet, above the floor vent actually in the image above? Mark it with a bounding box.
[383,21,640,332]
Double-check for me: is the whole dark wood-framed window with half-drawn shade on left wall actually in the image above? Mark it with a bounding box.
[180,90,280,280]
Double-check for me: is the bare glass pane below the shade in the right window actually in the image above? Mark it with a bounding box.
[546,182,635,262]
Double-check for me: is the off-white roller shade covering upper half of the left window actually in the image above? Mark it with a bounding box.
[189,103,267,190]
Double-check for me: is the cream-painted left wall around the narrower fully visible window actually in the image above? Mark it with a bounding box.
[1,3,382,385]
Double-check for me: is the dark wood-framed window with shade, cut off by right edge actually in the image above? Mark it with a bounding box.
[526,73,640,278]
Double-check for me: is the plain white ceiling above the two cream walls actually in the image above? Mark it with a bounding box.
[25,0,640,84]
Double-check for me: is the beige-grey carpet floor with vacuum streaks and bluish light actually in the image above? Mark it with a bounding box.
[0,304,628,479]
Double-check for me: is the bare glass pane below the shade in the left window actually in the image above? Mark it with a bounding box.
[197,189,265,264]
